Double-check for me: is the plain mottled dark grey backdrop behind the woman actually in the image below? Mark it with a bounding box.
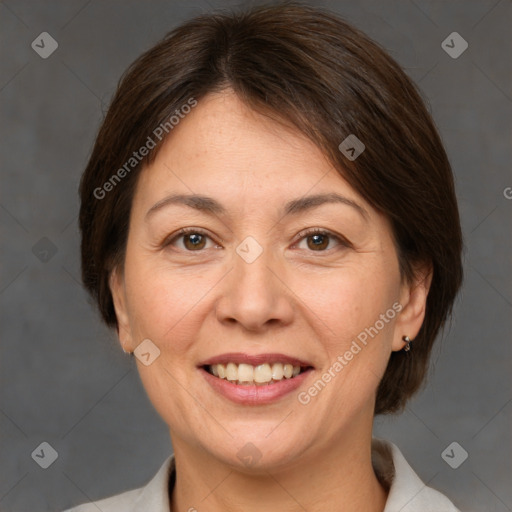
[0,0,512,512]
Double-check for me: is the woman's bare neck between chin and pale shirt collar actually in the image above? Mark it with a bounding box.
[170,425,387,512]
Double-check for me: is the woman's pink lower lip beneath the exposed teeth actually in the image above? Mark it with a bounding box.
[199,368,312,405]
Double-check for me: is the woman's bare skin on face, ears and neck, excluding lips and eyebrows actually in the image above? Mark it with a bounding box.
[111,91,429,512]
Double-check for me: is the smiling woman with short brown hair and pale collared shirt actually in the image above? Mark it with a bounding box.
[64,3,462,512]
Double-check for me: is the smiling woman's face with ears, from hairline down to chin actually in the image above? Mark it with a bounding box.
[111,93,426,467]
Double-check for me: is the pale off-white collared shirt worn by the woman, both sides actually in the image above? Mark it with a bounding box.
[64,437,460,512]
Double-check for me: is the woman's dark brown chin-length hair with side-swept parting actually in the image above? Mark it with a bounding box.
[80,2,462,414]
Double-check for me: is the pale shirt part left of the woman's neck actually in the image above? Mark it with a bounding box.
[60,455,175,512]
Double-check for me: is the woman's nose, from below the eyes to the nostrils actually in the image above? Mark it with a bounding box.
[216,245,294,331]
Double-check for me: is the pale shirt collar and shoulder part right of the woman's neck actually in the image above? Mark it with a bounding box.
[372,438,460,512]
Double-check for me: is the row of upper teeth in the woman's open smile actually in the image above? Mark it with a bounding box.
[209,363,300,384]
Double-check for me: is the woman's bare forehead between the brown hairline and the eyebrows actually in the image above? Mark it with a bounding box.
[133,91,370,214]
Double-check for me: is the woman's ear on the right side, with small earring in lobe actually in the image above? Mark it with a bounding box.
[393,264,433,351]
